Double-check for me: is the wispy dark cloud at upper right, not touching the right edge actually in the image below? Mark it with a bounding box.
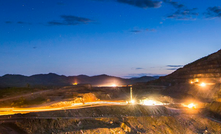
[164,0,199,20]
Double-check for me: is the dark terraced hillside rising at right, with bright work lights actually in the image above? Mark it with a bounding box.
[147,50,221,99]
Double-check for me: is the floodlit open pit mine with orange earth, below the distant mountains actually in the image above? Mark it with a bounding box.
[0,50,221,134]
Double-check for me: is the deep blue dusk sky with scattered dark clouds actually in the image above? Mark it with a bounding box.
[0,0,221,77]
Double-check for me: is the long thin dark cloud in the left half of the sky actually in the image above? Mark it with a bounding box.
[48,15,93,26]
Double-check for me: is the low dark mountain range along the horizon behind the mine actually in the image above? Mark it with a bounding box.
[0,73,156,87]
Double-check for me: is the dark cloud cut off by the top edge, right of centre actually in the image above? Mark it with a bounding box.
[117,0,162,8]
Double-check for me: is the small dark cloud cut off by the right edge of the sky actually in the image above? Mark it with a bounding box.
[204,6,221,18]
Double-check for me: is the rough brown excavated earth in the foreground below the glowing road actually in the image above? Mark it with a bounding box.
[0,105,221,134]
